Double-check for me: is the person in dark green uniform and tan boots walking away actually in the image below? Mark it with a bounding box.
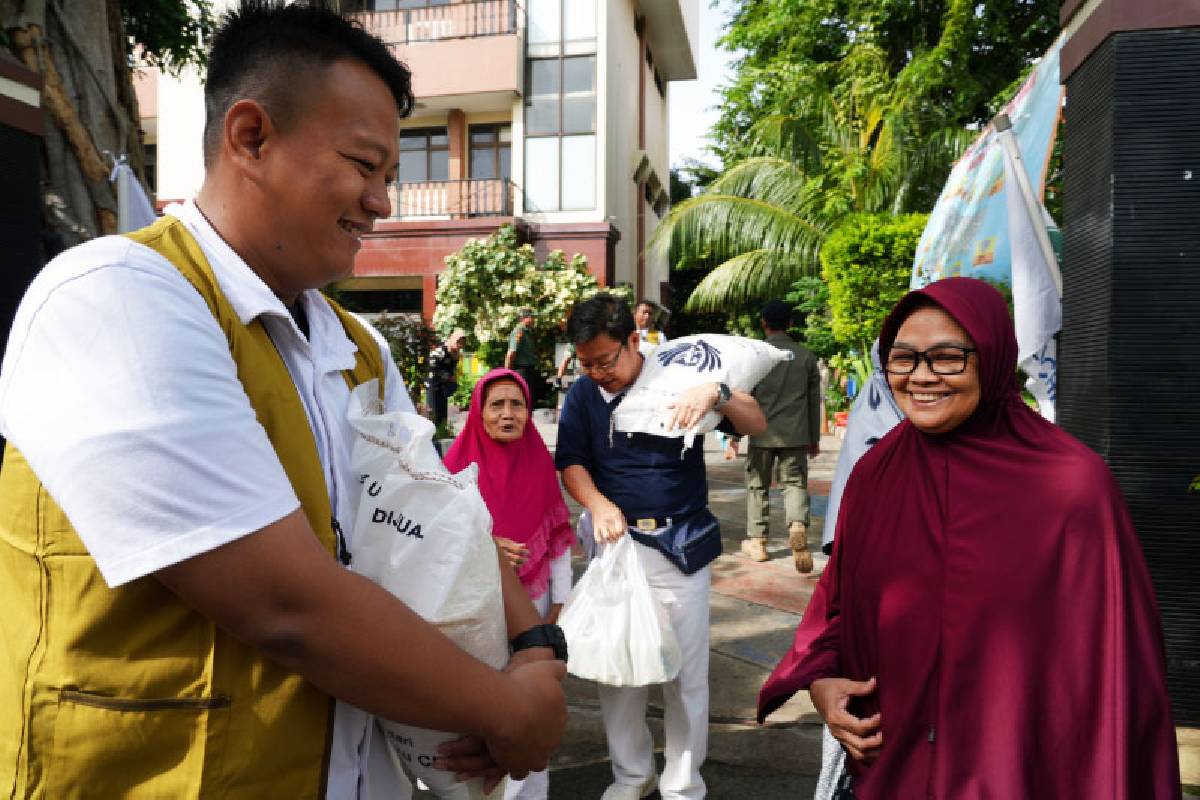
[734,300,821,572]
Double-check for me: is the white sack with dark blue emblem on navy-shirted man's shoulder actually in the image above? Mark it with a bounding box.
[612,333,796,449]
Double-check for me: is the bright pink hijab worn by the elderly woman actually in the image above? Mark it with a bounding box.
[443,369,575,599]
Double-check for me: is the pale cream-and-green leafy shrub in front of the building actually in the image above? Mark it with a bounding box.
[433,225,630,393]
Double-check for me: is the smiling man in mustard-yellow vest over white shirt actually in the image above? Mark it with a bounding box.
[0,0,566,800]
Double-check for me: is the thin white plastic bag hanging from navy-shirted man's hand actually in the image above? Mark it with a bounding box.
[558,536,683,686]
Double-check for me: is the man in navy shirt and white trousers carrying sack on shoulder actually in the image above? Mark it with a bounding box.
[554,293,767,800]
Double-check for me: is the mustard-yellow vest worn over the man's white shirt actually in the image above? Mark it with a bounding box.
[0,217,384,800]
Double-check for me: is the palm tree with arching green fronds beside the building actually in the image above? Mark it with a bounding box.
[650,91,971,312]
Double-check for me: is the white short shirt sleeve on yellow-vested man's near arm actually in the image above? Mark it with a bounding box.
[0,237,299,587]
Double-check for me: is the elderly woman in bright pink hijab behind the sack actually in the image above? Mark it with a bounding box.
[445,369,575,800]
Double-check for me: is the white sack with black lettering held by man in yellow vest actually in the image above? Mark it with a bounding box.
[348,380,509,800]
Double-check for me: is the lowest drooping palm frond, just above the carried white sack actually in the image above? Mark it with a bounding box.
[684,249,821,312]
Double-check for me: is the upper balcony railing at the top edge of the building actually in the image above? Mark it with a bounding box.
[356,0,517,44]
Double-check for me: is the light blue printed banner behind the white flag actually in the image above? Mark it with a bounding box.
[911,37,1063,289]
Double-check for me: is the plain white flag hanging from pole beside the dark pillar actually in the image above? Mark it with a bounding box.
[1000,136,1062,422]
